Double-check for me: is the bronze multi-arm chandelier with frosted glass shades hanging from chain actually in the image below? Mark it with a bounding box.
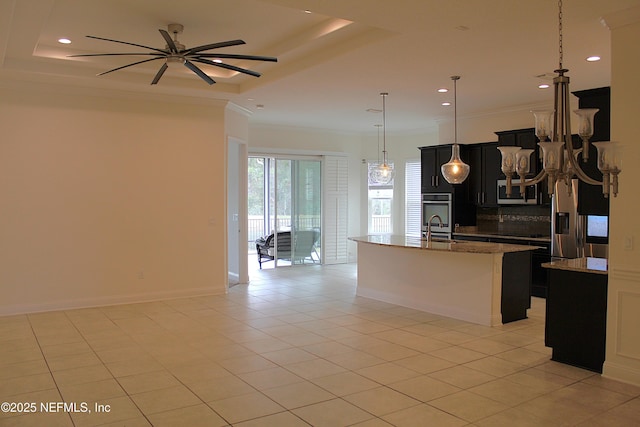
[498,0,621,197]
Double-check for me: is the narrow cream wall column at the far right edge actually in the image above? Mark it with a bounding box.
[603,7,640,386]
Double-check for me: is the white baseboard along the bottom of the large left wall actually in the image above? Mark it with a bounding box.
[0,287,226,316]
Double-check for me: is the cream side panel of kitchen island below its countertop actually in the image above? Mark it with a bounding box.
[357,243,503,326]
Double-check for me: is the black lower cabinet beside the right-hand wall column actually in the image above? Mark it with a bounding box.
[544,269,607,373]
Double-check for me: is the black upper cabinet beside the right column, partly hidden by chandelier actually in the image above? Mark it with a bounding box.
[573,87,611,215]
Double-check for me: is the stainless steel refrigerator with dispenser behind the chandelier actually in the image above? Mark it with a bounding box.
[551,179,608,258]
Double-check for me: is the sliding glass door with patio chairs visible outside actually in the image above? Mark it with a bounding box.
[249,156,322,267]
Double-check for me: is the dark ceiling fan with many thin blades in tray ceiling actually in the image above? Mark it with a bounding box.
[70,24,278,85]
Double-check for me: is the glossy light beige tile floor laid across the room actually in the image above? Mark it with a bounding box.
[0,265,640,427]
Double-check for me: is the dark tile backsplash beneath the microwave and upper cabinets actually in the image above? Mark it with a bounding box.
[476,205,551,236]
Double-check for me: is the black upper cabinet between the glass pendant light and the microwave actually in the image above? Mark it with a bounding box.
[468,142,504,207]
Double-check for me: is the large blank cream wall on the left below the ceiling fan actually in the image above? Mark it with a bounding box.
[0,80,227,315]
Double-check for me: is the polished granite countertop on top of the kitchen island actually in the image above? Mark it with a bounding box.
[349,234,538,254]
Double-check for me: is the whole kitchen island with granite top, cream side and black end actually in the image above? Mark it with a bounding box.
[350,235,536,326]
